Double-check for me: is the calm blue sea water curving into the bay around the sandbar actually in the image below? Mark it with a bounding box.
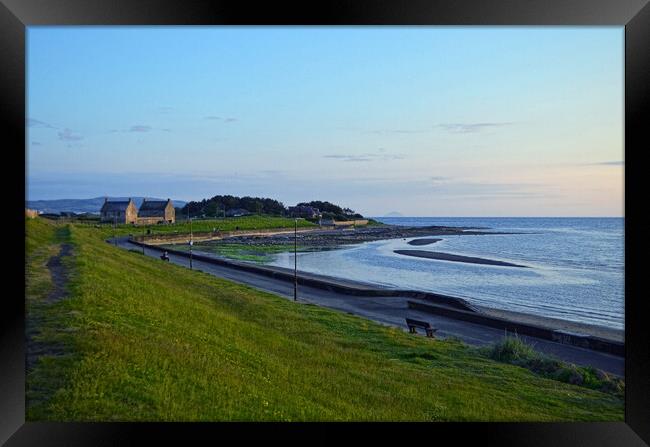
[272,217,624,329]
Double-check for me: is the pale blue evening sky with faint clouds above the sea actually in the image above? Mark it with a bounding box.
[26,26,625,217]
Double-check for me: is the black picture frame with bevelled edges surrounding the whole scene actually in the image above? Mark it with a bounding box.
[0,0,650,447]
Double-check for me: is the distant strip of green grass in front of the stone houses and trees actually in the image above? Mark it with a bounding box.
[75,216,317,237]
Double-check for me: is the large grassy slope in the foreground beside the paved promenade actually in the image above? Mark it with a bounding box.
[27,219,623,421]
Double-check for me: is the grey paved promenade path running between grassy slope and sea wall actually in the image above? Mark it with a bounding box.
[117,238,625,377]
